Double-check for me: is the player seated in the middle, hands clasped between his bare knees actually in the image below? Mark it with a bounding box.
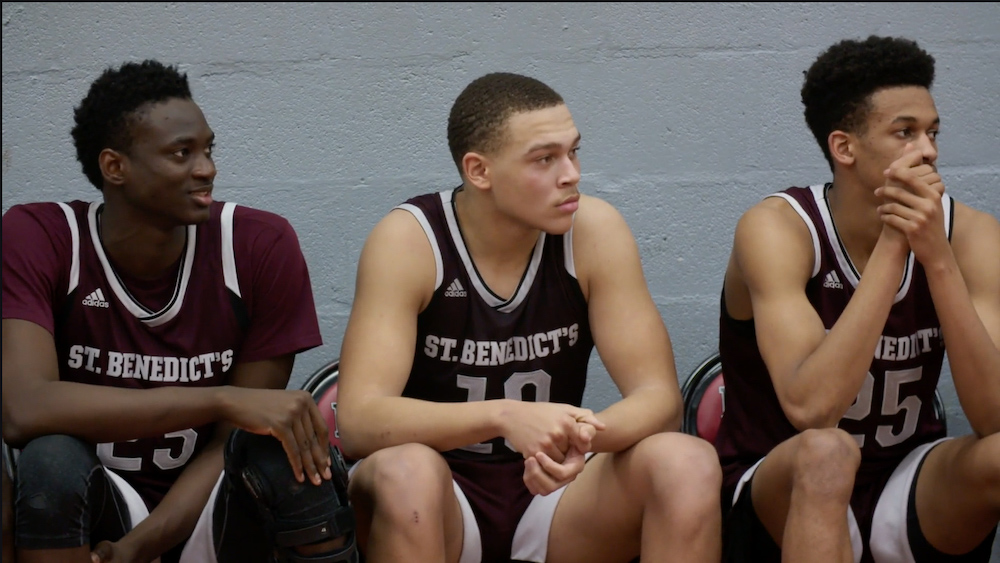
[338,73,721,563]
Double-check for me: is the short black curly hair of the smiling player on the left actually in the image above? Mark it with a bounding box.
[71,59,191,190]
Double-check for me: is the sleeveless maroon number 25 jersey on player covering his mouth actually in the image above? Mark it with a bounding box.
[715,184,953,492]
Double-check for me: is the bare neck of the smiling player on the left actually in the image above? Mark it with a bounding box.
[98,203,187,279]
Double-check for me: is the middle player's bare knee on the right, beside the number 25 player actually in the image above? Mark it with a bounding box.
[633,432,722,508]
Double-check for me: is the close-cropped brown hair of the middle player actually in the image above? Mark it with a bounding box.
[448,72,565,174]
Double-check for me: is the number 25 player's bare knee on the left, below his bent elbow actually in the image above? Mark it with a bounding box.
[793,428,861,498]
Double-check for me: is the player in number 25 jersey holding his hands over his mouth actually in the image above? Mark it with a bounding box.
[716,36,1000,563]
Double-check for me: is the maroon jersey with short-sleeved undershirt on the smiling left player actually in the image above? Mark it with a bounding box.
[3,201,321,505]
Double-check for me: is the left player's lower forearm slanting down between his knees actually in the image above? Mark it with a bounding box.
[122,439,225,561]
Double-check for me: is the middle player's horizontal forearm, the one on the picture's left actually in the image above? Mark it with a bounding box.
[337,397,505,459]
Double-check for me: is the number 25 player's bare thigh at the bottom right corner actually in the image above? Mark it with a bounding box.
[914,434,1000,554]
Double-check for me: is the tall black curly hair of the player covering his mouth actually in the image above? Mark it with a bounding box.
[802,35,934,170]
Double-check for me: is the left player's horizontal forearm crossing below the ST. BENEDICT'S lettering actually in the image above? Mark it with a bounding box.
[3,381,225,446]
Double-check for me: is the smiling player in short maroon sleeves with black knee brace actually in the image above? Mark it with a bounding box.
[3,60,353,563]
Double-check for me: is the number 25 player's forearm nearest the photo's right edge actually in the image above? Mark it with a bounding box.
[926,259,1000,436]
